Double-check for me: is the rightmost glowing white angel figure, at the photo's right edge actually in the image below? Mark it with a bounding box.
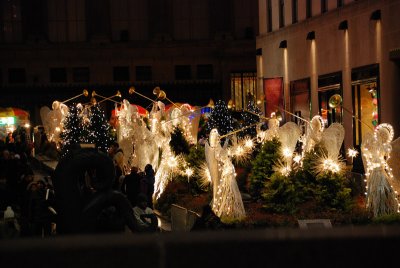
[361,124,399,217]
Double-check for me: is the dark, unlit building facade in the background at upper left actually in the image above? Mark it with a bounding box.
[0,0,258,123]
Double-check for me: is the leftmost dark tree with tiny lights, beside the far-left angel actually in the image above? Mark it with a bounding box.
[60,105,84,150]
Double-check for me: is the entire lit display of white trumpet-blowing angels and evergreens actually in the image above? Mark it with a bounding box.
[50,87,400,227]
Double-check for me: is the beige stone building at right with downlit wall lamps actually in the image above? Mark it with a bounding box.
[256,0,400,151]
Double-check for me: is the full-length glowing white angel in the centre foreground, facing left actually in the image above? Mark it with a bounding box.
[205,129,246,222]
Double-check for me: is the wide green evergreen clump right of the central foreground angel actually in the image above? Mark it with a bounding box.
[262,144,354,214]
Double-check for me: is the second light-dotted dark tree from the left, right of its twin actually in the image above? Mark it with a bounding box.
[87,105,113,153]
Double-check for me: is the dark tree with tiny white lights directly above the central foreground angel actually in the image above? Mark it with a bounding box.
[207,100,234,139]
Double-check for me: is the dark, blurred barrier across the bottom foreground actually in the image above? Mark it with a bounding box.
[0,226,400,268]
